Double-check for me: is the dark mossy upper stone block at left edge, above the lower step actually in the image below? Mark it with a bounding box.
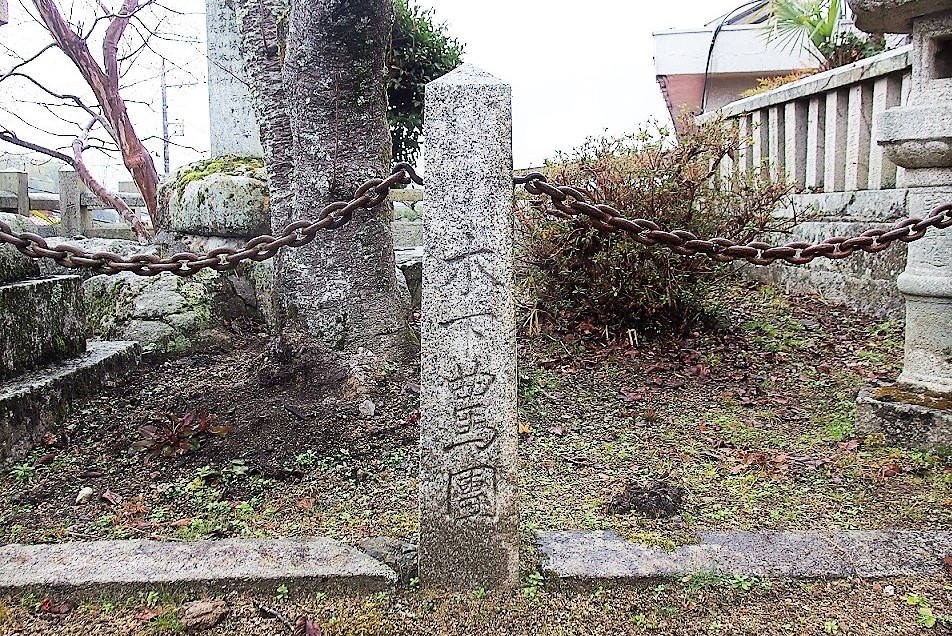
[0,276,86,381]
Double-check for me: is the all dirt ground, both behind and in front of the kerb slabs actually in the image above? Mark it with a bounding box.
[0,285,952,634]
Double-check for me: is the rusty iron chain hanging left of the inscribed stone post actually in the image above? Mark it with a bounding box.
[0,163,423,276]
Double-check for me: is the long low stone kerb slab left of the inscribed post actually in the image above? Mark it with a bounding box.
[0,537,397,594]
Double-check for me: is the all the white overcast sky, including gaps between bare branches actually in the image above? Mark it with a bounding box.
[0,0,742,182]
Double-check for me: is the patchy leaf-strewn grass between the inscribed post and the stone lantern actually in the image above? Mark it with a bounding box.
[520,287,952,545]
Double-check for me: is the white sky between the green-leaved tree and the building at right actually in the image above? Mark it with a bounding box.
[420,0,743,166]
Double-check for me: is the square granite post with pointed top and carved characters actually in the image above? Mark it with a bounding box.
[420,65,519,590]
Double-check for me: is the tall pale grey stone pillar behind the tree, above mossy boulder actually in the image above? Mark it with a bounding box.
[205,0,264,157]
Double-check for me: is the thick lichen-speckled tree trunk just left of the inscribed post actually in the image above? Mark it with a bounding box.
[276,0,410,369]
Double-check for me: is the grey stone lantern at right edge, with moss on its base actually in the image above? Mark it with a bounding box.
[849,0,952,448]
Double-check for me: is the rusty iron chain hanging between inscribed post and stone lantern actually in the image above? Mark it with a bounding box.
[513,172,952,265]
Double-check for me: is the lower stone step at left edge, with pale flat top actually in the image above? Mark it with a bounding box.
[0,340,139,462]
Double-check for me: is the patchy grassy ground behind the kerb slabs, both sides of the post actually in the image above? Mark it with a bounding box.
[0,287,952,552]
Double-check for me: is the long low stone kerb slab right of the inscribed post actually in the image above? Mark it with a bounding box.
[539,530,952,584]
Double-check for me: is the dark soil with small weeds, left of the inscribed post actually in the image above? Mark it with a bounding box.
[0,325,418,541]
